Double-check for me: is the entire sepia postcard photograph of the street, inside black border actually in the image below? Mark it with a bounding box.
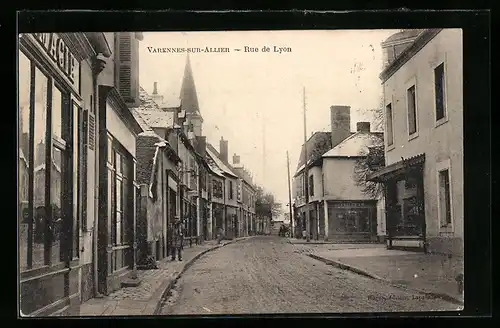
[17,24,465,317]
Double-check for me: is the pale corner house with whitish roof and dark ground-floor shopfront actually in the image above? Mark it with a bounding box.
[322,122,383,241]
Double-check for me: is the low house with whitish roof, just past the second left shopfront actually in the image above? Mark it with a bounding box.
[130,88,181,265]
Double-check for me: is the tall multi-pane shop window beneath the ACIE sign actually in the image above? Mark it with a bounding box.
[18,51,78,271]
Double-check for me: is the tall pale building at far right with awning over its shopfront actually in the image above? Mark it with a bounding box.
[369,29,464,255]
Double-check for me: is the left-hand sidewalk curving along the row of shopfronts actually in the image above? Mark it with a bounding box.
[80,237,250,316]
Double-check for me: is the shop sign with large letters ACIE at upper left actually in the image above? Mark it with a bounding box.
[34,33,80,90]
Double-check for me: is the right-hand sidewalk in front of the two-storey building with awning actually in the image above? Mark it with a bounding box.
[302,247,464,304]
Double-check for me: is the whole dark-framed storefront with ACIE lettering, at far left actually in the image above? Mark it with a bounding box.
[18,33,103,316]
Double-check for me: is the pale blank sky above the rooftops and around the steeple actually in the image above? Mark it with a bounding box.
[139,30,396,209]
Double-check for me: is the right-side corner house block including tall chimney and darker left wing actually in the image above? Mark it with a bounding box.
[293,106,384,242]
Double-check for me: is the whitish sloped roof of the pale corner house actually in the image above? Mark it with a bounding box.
[323,132,384,157]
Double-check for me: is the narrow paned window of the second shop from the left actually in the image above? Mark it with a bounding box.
[108,136,133,271]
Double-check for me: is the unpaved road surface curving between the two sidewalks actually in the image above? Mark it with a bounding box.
[162,236,458,315]
